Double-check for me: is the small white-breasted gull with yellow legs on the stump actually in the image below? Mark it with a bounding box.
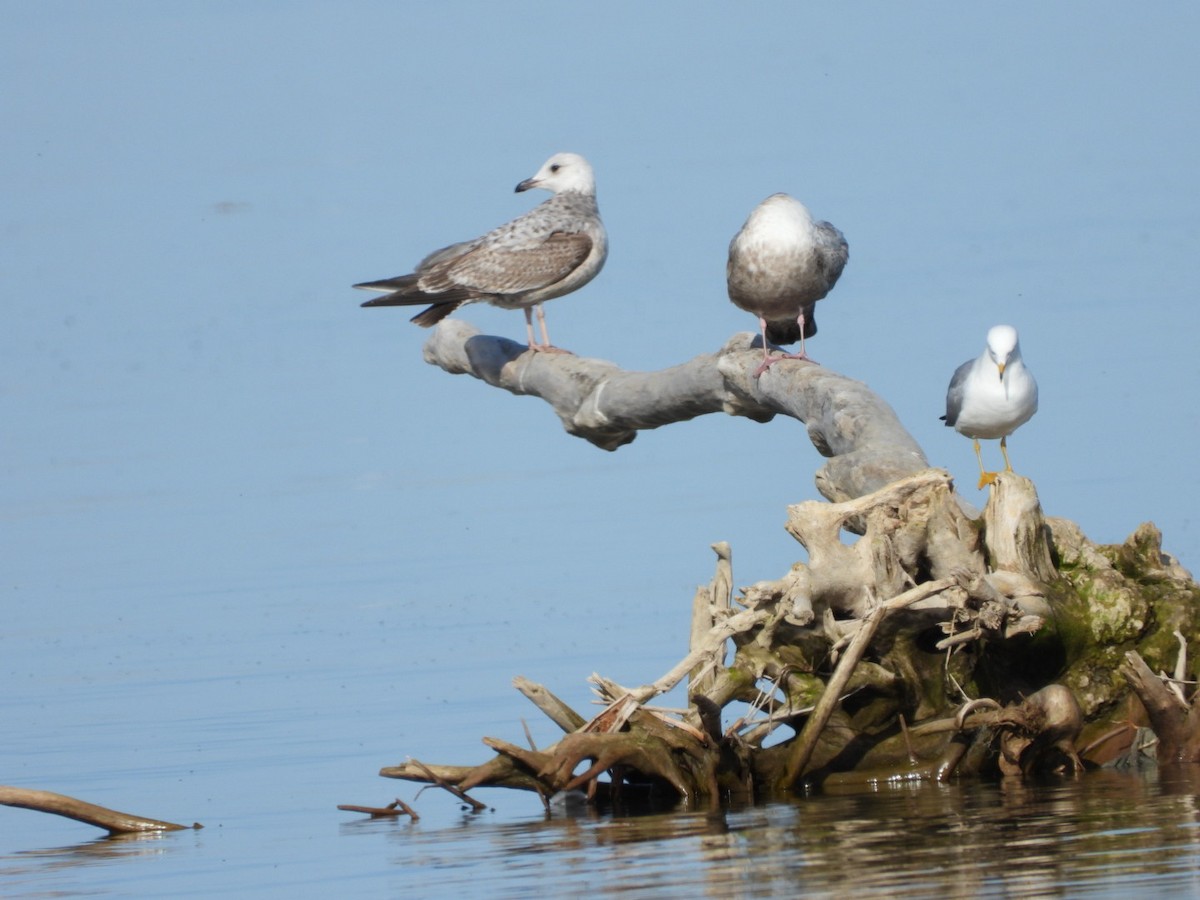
[942,325,1038,487]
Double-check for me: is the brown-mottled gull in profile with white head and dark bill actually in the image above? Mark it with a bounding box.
[354,154,608,350]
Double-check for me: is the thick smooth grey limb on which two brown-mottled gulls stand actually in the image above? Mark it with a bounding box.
[425,319,929,500]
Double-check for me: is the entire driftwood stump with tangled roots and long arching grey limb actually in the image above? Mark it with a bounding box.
[380,319,1200,808]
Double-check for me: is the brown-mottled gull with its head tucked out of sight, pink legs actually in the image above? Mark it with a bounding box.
[725,193,850,378]
